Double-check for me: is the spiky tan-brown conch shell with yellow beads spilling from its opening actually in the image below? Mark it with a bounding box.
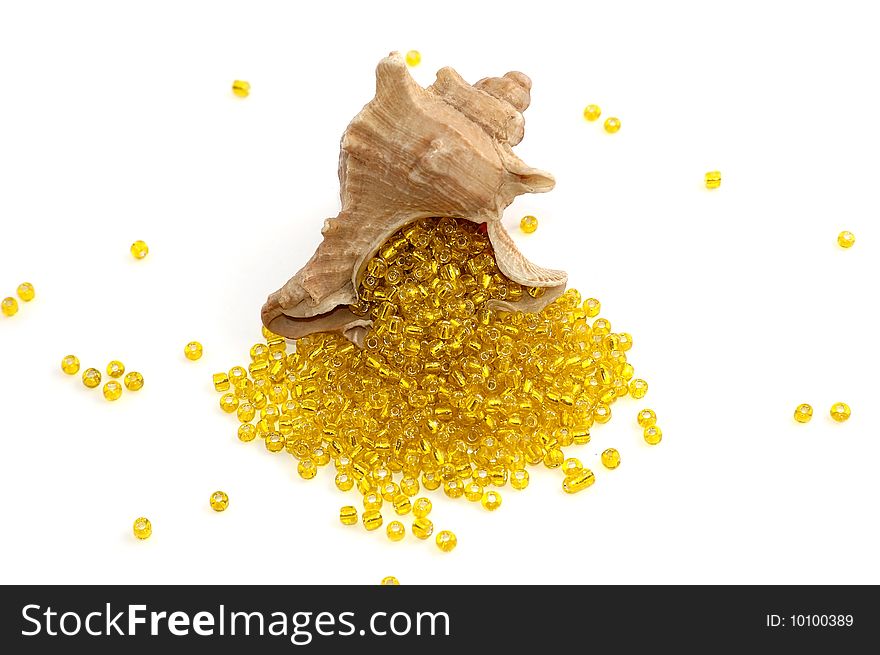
[262,52,567,343]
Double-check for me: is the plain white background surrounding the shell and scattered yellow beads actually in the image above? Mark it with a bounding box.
[0,0,880,584]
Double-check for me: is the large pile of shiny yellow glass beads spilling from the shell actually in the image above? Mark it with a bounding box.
[214,219,661,551]
